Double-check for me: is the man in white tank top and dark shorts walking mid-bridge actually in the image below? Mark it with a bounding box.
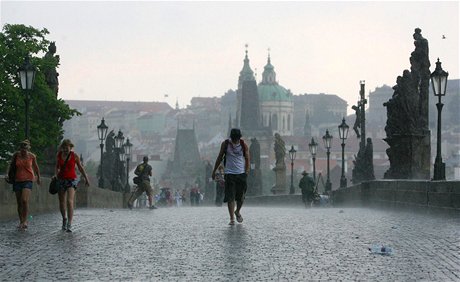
[212,128,249,225]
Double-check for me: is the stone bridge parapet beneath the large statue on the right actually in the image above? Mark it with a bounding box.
[333,180,460,211]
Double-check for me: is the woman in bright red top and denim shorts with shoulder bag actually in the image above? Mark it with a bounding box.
[53,139,90,232]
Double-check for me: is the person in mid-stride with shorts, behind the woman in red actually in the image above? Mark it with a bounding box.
[128,156,157,209]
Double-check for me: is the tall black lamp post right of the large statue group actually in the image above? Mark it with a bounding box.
[431,58,449,180]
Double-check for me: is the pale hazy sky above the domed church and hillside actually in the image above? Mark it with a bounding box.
[0,0,459,113]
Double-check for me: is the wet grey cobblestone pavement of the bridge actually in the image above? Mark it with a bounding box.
[0,207,460,281]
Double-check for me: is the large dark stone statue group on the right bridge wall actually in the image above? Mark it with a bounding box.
[383,28,431,179]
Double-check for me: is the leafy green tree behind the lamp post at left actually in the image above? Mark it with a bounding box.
[0,24,80,171]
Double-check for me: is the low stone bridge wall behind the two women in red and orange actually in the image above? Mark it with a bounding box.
[0,176,128,220]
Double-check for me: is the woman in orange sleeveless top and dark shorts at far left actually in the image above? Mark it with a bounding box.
[8,140,41,230]
